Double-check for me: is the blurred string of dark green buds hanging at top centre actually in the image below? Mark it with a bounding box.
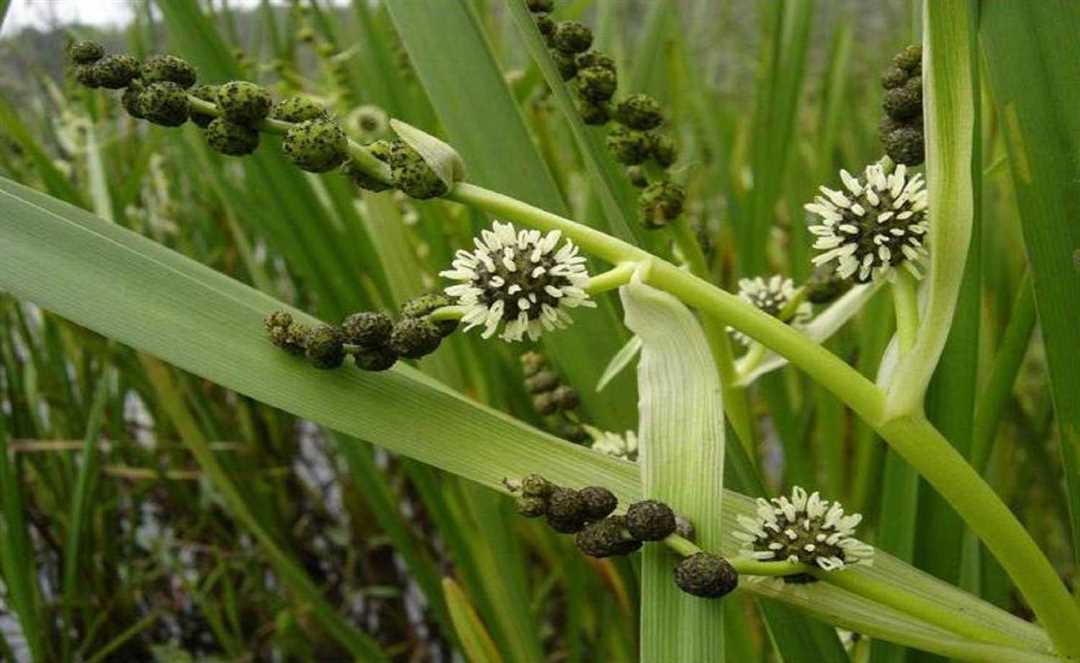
[527,0,686,229]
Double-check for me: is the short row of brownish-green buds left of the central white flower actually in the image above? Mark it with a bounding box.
[265,295,458,371]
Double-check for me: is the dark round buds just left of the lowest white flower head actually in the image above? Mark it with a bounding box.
[507,474,739,598]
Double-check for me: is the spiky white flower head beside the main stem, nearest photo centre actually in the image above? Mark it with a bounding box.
[440,221,596,341]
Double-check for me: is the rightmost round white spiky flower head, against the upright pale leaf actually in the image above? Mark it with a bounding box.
[805,163,928,283]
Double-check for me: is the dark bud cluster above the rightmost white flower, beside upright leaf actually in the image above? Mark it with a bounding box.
[878,44,926,166]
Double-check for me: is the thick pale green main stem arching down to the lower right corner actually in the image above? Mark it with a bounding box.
[446,182,1080,660]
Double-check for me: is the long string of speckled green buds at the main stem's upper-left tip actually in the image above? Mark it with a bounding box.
[69,41,447,199]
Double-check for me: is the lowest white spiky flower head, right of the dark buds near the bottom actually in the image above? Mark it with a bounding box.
[733,486,874,582]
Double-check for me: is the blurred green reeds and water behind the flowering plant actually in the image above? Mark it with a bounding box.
[0,0,1062,662]
